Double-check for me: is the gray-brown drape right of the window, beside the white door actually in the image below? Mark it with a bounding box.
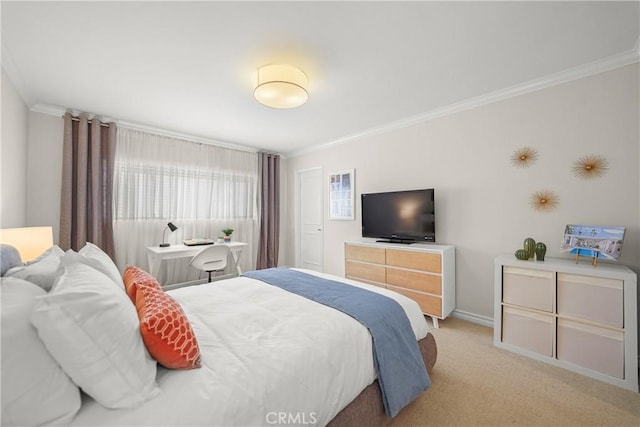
[256,153,280,270]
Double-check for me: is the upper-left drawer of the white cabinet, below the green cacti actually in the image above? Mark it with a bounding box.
[502,267,555,312]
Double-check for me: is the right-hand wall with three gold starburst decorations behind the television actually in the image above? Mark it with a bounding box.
[285,64,640,319]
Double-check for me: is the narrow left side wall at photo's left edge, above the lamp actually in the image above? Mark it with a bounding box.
[0,68,29,228]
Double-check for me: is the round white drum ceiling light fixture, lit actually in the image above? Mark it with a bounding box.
[253,64,309,108]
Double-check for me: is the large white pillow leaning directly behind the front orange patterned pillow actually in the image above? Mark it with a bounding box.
[31,263,159,408]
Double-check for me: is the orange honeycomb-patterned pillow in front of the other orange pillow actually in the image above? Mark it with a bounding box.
[136,283,200,369]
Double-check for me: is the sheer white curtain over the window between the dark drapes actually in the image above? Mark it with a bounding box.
[113,127,260,283]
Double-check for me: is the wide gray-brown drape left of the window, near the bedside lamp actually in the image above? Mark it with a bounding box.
[59,113,116,259]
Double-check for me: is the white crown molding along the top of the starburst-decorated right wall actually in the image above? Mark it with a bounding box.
[287,48,640,158]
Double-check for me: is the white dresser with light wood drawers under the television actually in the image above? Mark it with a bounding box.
[344,241,456,328]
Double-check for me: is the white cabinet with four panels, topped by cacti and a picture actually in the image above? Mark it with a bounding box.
[493,256,638,392]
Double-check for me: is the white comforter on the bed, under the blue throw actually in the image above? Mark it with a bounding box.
[73,270,427,426]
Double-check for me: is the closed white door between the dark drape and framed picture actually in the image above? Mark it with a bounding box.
[296,168,324,272]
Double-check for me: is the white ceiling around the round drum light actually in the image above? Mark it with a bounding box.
[0,1,640,154]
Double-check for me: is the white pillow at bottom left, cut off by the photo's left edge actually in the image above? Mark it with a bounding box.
[0,277,80,426]
